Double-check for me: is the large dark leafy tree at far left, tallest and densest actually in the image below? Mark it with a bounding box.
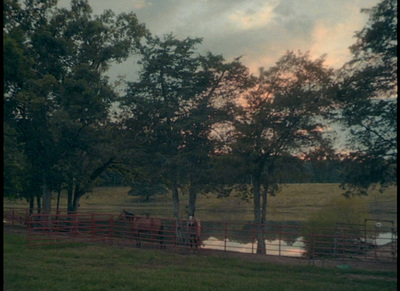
[3,0,147,212]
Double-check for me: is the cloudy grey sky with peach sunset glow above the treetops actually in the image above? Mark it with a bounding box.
[59,0,379,81]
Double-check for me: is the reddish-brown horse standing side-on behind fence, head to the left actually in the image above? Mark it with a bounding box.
[119,209,165,248]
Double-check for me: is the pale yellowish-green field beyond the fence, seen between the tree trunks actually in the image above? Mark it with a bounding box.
[4,184,397,225]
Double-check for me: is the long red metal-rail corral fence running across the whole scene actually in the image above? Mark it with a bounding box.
[3,208,397,262]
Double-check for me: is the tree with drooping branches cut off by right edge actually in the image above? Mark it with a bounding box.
[336,0,398,195]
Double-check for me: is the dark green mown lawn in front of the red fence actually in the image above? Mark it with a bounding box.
[3,232,397,291]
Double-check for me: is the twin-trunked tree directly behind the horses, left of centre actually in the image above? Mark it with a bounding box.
[123,35,247,224]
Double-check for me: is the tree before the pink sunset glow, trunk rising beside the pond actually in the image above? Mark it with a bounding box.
[232,52,332,253]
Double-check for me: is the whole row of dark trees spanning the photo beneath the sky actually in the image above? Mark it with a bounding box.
[3,0,397,253]
